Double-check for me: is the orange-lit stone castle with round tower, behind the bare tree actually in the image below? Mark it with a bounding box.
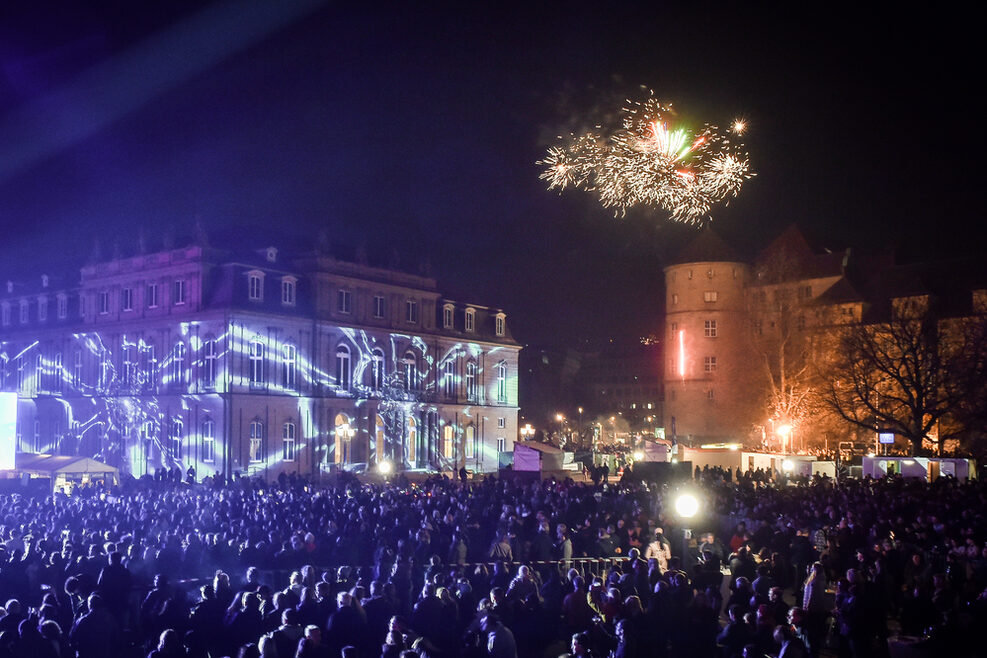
[664,226,987,449]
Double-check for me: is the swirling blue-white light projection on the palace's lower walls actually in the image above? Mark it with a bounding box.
[0,318,517,476]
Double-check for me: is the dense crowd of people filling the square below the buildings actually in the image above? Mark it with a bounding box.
[0,462,987,658]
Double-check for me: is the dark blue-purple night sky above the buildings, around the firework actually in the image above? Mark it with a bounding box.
[0,0,985,344]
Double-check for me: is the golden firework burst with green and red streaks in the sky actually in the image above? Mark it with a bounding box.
[537,89,754,224]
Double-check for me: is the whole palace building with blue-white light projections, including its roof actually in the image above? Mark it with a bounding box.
[0,245,520,477]
